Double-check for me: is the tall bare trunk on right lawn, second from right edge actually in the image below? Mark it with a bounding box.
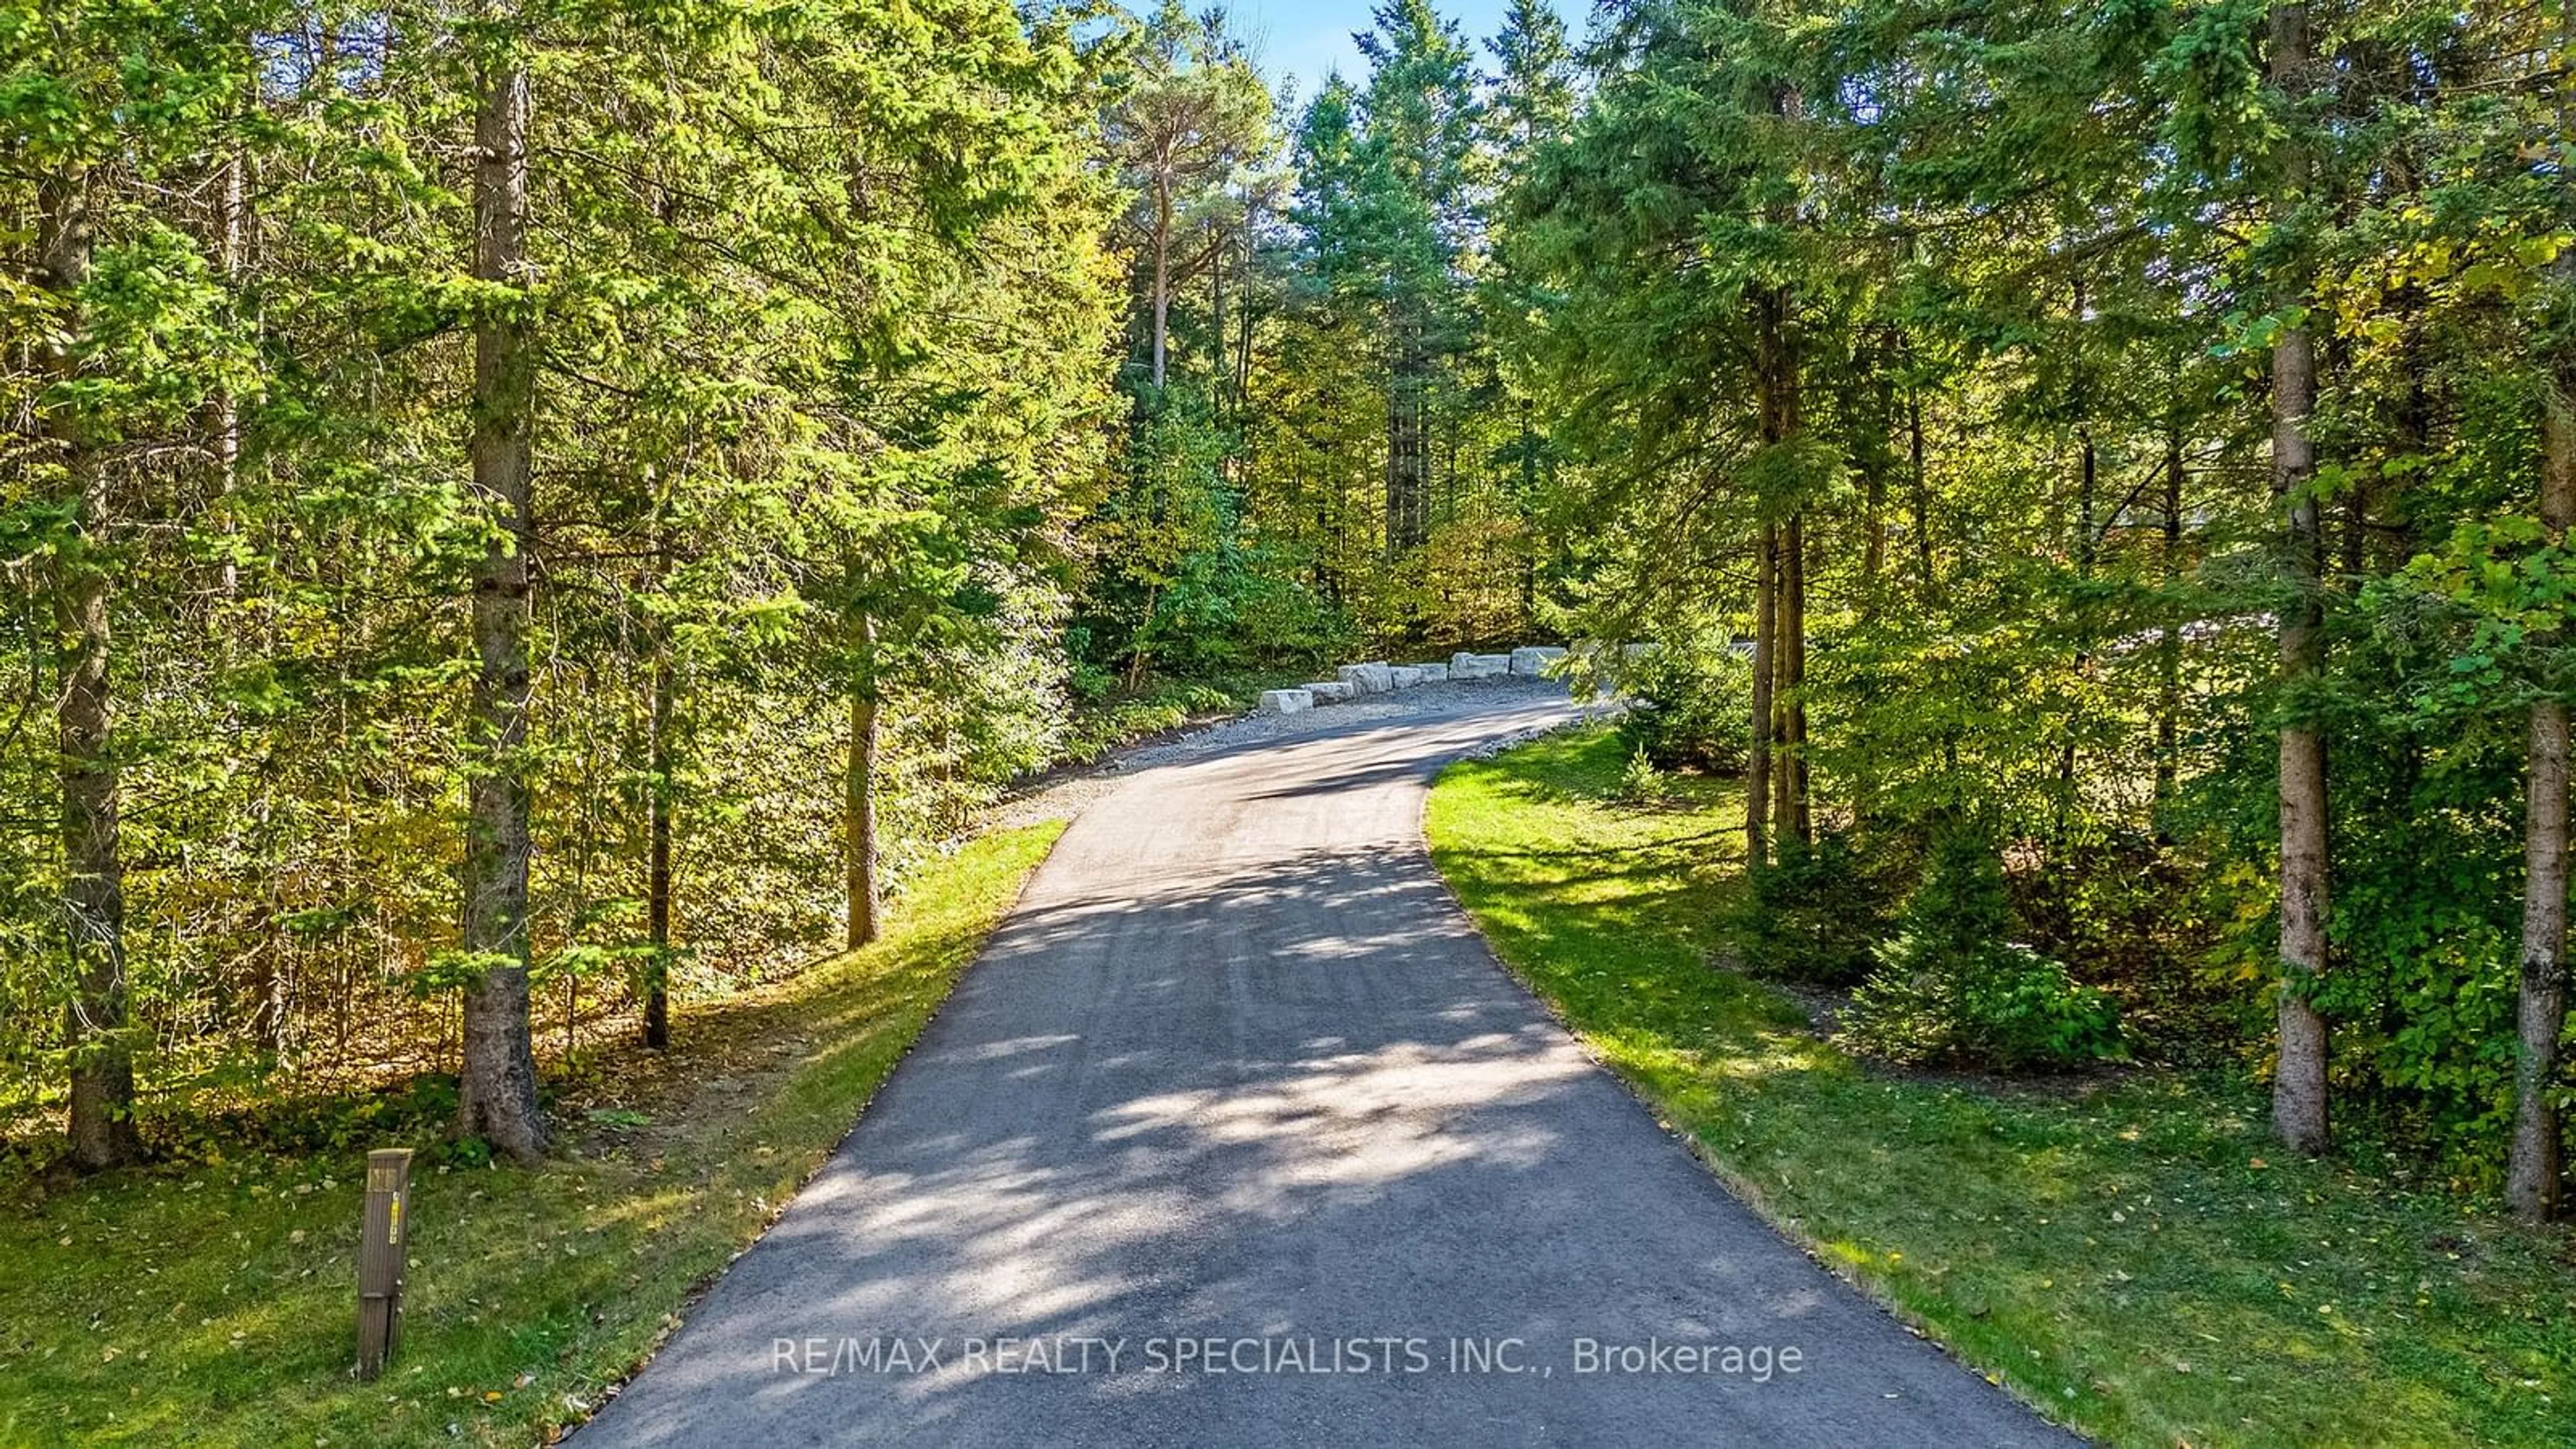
[2269,5,2328,1152]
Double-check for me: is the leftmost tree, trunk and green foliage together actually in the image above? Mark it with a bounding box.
[0,5,252,1168]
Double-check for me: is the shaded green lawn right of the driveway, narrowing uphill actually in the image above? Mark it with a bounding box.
[1430,733,2576,1444]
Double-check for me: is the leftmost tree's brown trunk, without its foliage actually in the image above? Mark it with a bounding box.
[36,168,142,1168]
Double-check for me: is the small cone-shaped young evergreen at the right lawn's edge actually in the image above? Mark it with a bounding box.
[1842,830,2123,1073]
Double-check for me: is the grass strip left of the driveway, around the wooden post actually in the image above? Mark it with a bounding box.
[0,822,1061,1446]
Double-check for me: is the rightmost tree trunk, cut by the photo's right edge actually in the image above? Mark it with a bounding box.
[2504,239,2576,1222]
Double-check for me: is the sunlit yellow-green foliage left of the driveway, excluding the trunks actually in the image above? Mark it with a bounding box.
[0,0,1113,1134]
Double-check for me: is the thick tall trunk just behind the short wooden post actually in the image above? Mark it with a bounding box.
[459,39,546,1163]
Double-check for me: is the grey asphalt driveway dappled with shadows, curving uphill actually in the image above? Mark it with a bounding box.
[580,684,2066,1449]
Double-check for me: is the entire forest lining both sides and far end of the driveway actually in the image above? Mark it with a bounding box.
[0,0,2576,1217]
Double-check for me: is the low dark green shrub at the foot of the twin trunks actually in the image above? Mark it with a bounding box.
[1744,830,1911,985]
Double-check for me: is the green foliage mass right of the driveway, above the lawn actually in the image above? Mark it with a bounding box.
[1499,0,2576,1181]
